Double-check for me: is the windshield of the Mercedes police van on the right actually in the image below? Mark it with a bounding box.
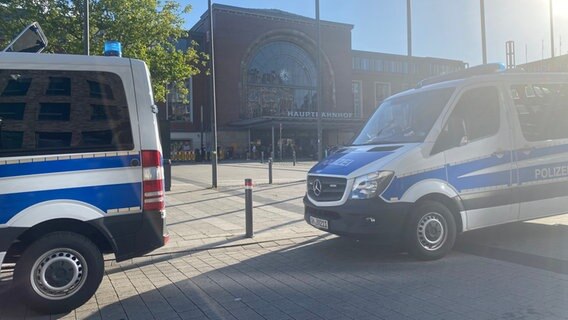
[353,87,455,145]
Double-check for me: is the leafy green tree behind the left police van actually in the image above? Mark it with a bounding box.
[0,0,207,102]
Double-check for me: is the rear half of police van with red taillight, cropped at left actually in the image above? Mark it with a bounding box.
[0,24,168,312]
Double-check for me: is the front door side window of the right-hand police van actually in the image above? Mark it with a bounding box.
[432,87,500,154]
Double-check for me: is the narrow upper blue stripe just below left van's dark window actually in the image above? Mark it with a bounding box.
[0,155,140,178]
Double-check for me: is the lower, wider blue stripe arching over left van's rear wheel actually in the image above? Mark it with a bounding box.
[0,183,142,224]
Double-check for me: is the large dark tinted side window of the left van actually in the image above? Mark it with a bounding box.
[0,70,134,156]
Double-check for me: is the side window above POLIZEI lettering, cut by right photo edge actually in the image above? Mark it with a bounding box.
[510,83,568,142]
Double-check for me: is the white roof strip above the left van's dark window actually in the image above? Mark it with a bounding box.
[0,52,134,67]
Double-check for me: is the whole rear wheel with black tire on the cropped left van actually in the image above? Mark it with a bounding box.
[14,232,104,313]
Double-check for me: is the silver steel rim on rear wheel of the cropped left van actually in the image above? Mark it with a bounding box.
[30,248,87,300]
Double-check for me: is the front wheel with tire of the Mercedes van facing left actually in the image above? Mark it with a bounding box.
[406,200,456,260]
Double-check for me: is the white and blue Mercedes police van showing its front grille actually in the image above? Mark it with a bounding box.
[304,65,568,260]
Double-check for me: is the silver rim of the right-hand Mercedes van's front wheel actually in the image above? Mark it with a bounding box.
[416,212,448,251]
